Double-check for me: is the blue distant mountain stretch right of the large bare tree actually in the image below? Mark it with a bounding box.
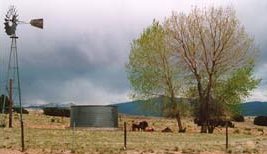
[241,101,267,116]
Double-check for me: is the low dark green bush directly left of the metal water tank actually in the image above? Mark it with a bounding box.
[43,107,70,117]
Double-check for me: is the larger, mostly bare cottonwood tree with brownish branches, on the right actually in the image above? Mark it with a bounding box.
[164,7,258,133]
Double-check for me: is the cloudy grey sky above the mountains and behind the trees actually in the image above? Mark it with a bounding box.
[0,0,267,105]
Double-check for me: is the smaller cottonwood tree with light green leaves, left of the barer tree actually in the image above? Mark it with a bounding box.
[126,21,184,131]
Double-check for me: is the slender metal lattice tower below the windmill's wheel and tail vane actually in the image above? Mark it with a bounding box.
[7,35,24,151]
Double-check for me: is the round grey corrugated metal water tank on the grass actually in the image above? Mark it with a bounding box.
[70,105,118,128]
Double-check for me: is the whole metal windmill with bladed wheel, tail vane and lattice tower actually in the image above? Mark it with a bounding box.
[3,6,43,151]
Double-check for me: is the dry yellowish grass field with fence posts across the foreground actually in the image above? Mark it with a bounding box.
[0,112,267,154]
